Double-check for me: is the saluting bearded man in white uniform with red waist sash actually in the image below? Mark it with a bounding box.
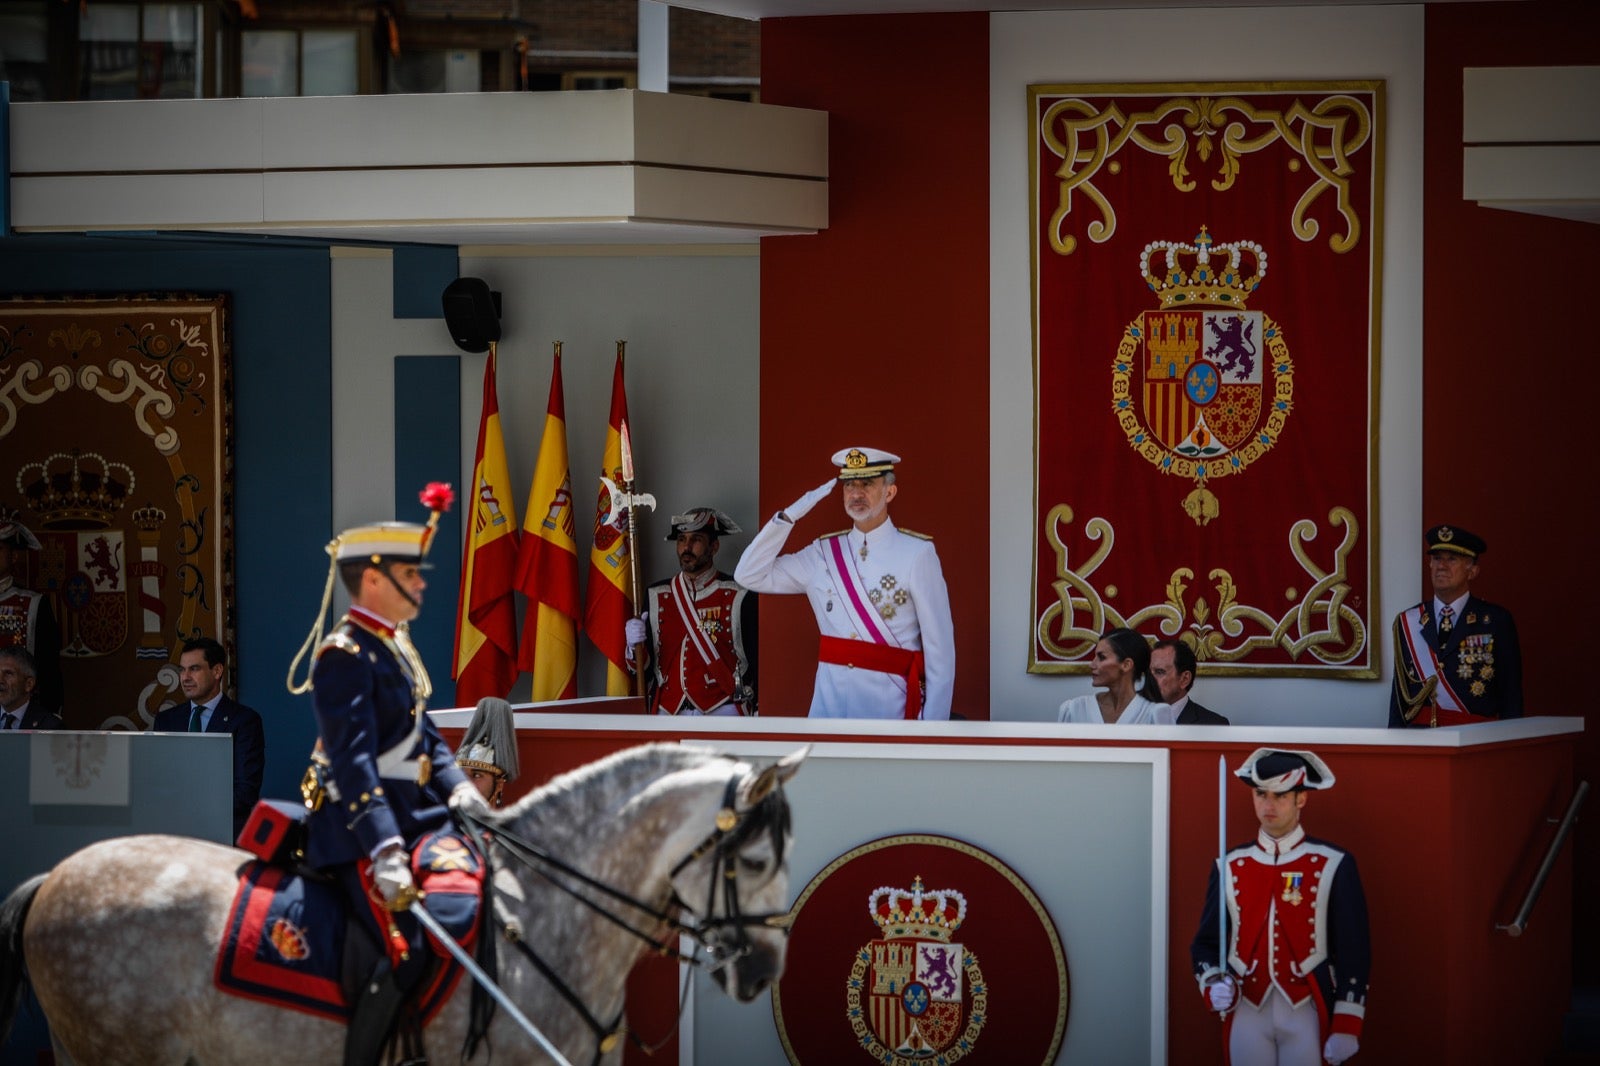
[733,448,955,719]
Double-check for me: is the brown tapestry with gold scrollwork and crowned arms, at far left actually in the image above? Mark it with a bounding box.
[0,295,237,730]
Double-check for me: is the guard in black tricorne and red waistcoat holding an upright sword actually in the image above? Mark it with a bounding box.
[1189,747,1371,1066]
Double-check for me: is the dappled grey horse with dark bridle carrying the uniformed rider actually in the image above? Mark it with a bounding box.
[0,744,805,1066]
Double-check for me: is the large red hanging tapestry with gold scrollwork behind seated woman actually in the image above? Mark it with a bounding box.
[1029,82,1382,677]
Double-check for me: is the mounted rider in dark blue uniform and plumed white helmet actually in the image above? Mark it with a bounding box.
[290,483,488,1066]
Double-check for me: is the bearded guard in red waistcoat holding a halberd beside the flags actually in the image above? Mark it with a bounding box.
[626,507,757,717]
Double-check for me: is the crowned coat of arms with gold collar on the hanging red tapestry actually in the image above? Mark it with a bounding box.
[1112,226,1294,525]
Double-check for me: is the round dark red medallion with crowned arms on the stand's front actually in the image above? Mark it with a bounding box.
[773,834,1067,1066]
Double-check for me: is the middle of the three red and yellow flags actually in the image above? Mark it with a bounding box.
[517,341,578,703]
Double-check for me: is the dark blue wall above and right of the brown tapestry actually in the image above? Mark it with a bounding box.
[0,237,332,799]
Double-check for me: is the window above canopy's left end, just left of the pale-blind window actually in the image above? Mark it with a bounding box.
[78,3,205,99]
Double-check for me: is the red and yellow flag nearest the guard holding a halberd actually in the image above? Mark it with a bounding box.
[584,346,634,696]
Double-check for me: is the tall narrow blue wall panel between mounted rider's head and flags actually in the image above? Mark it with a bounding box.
[395,355,472,707]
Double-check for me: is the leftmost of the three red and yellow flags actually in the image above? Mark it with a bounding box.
[454,344,517,707]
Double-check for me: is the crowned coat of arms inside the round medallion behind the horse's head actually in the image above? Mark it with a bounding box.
[845,877,989,1066]
